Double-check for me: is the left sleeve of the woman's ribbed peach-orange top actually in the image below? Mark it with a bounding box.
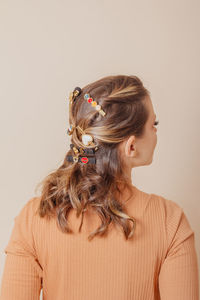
[0,198,42,300]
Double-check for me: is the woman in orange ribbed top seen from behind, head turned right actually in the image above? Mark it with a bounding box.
[0,75,199,300]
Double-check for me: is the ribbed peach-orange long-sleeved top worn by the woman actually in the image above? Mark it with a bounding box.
[0,186,199,300]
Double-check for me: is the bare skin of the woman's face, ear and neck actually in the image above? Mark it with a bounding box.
[120,97,157,183]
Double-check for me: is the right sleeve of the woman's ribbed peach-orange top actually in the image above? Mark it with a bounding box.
[159,200,199,300]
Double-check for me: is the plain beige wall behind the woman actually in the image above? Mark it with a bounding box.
[0,0,200,296]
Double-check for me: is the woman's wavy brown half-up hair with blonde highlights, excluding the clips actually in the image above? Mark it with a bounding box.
[34,75,150,241]
